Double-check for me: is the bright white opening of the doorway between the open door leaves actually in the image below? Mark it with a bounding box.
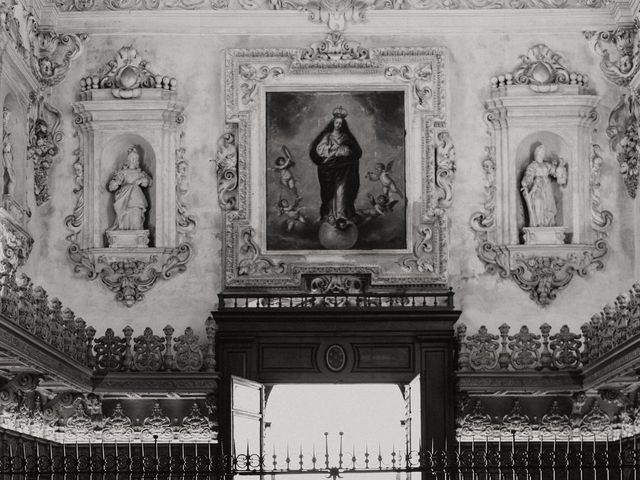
[264,384,407,470]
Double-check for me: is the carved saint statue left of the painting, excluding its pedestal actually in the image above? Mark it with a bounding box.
[107,145,151,230]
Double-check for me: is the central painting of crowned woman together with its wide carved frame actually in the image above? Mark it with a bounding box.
[222,31,456,288]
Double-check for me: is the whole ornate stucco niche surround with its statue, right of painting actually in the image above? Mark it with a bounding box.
[471,45,613,306]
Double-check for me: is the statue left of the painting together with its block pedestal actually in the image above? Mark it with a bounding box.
[107,145,151,247]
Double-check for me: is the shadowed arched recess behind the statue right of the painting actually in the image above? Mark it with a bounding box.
[514,130,573,243]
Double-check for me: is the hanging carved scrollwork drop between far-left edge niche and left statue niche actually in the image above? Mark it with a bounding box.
[27,92,63,206]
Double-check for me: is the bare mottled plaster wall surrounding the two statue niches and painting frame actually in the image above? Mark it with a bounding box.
[17,27,638,333]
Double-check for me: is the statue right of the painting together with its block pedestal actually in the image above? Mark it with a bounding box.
[520,144,567,244]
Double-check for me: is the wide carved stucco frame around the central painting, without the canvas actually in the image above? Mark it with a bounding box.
[224,31,455,290]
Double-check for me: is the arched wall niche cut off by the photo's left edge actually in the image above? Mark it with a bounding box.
[2,93,28,209]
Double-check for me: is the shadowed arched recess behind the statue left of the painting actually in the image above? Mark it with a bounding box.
[98,133,159,247]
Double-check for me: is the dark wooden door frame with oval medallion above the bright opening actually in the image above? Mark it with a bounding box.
[213,309,461,462]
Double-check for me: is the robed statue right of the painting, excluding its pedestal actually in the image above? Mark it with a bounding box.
[520,144,567,227]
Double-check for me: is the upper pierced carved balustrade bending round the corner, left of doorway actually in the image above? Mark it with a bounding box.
[0,268,216,374]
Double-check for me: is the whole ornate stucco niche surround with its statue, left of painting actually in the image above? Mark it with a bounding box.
[65,46,196,307]
